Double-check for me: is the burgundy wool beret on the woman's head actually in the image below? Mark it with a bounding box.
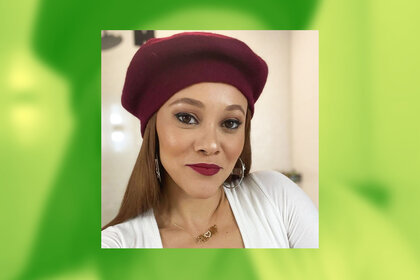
[121,32,268,135]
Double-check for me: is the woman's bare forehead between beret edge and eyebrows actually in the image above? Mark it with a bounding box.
[165,82,248,110]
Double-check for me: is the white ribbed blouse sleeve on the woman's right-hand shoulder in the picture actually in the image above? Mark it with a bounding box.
[254,171,319,248]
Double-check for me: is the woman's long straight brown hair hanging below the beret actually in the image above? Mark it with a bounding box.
[102,109,251,230]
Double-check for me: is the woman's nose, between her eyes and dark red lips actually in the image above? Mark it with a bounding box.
[194,124,220,156]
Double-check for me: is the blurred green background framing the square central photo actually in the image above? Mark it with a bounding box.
[0,0,420,279]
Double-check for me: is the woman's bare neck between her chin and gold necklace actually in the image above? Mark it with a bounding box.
[158,175,225,232]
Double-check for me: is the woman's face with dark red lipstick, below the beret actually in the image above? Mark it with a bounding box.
[156,83,248,198]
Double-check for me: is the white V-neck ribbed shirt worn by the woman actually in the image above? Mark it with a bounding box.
[102,171,318,248]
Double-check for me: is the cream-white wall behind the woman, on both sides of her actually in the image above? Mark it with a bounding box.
[102,30,318,225]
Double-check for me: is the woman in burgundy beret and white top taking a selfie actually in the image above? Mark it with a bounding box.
[102,32,318,248]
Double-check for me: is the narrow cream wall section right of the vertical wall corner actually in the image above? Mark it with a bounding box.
[290,31,319,209]
